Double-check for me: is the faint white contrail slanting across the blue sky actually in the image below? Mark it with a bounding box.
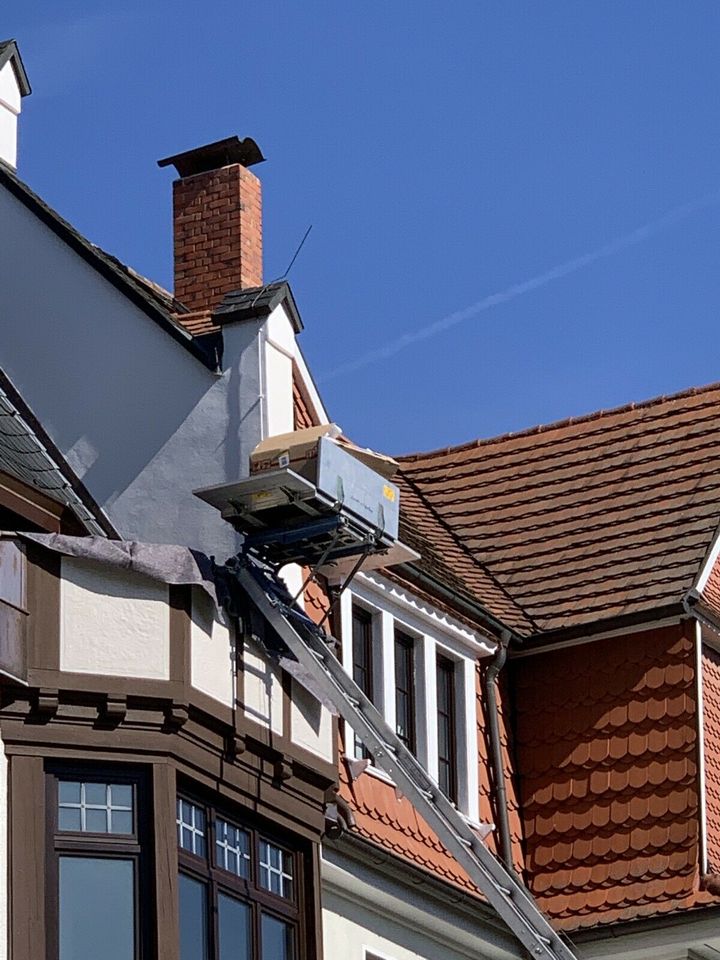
[319,190,720,382]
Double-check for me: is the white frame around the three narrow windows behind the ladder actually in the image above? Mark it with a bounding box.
[340,572,495,823]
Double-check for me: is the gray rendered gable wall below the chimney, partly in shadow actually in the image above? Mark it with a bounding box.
[0,187,262,560]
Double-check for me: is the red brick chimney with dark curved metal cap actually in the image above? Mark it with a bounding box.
[158,137,265,321]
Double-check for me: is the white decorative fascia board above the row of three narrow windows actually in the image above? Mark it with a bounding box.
[351,572,497,657]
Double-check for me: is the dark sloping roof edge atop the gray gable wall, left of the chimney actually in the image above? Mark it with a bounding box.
[0,160,215,371]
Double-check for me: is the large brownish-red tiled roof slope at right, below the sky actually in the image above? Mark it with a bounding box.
[398,384,720,631]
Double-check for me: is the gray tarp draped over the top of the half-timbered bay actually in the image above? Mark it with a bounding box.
[18,533,337,714]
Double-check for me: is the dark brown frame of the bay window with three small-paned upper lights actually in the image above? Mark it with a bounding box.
[177,784,315,960]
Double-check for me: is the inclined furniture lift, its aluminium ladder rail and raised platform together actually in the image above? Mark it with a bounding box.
[196,437,576,960]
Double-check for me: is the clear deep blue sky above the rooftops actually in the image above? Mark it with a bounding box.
[0,0,720,453]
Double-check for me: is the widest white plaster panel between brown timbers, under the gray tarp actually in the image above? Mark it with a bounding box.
[60,557,170,680]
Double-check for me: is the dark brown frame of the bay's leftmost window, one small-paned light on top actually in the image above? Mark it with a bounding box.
[45,762,156,960]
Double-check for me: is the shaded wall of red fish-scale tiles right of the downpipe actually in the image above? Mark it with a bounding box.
[511,623,712,929]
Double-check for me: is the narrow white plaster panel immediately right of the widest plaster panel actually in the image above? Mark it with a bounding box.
[190,590,235,707]
